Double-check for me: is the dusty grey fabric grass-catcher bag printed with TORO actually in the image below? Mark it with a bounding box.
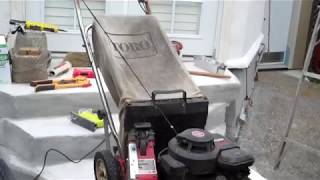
[92,16,203,106]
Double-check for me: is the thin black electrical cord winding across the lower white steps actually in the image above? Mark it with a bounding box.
[33,139,105,180]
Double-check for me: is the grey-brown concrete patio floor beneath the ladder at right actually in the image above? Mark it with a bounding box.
[240,71,320,180]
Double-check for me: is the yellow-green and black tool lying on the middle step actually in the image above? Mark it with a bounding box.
[71,109,104,132]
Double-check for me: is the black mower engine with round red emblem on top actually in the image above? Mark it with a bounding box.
[159,129,254,180]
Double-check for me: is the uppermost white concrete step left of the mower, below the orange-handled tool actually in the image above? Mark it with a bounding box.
[0,80,118,120]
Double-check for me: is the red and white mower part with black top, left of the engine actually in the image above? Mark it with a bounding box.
[128,123,158,180]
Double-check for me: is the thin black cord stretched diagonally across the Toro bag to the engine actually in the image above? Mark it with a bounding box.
[81,0,178,135]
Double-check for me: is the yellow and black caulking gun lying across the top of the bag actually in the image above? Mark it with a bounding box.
[9,19,66,34]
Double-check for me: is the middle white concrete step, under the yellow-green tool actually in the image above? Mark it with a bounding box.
[0,114,119,164]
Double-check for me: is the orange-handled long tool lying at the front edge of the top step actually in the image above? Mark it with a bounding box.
[30,76,91,92]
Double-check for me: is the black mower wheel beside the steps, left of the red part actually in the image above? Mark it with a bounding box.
[94,150,120,180]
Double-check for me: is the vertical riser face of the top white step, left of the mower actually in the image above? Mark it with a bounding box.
[0,93,118,120]
